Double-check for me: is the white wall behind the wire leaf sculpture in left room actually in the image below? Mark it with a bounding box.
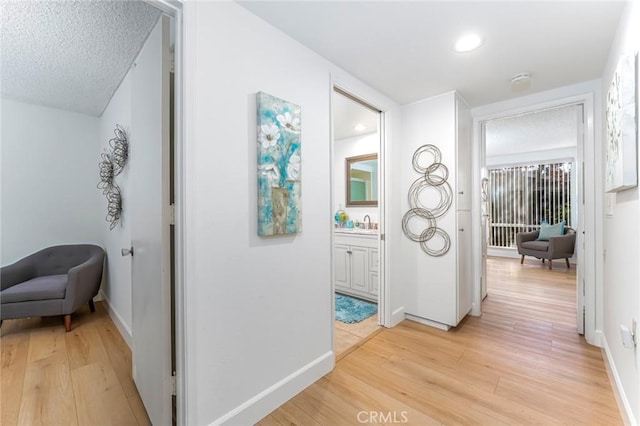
[96,71,135,344]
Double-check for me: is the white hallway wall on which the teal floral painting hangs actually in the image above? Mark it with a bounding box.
[184,2,400,424]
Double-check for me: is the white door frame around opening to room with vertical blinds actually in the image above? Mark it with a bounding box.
[471,81,603,346]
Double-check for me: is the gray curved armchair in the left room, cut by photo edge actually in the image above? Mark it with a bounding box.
[0,244,105,332]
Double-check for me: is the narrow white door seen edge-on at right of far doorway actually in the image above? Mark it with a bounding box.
[575,104,585,334]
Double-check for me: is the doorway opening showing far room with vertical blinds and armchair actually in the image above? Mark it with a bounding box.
[481,103,585,334]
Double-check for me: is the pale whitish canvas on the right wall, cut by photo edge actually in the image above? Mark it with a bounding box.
[605,53,638,192]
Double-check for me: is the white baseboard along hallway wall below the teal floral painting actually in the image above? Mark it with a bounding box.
[210,351,335,426]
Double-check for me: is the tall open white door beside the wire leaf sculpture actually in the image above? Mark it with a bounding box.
[129,16,172,425]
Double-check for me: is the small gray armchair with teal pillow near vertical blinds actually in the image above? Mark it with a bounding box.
[516,227,576,269]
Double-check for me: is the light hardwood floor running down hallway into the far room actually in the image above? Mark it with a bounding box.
[260,258,622,426]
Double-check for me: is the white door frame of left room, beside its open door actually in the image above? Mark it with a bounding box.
[144,0,189,425]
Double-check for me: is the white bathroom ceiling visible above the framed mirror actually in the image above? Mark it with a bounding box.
[332,92,380,140]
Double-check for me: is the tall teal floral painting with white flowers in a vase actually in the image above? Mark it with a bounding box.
[256,92,302,236]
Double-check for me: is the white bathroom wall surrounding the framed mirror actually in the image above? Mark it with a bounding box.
[333,132,380,222]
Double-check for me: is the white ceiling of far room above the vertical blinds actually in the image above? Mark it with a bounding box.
[485,105,578,157]
